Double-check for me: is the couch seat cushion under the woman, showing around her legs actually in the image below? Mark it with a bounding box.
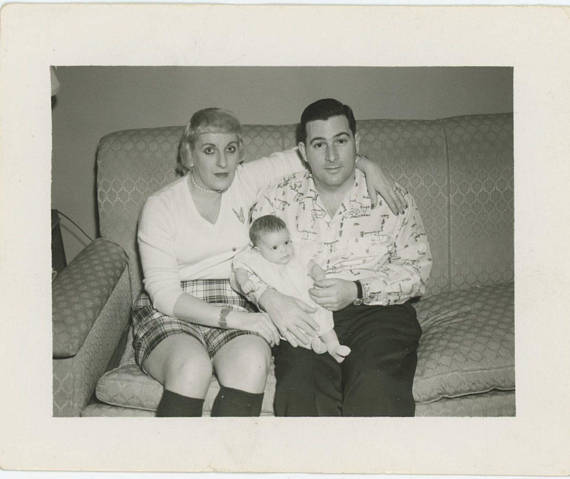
[96,362,275,415]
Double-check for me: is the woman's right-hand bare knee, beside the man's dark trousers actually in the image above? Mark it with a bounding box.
[214,335,271,393]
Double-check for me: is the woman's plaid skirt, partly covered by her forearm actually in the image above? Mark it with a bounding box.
[132,279,257,372]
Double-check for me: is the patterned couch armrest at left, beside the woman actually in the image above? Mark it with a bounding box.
[52,238,131,416]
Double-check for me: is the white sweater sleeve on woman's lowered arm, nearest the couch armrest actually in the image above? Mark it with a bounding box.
[137,196,183,316]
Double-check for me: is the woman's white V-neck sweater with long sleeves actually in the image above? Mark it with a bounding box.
[138,149,303,316]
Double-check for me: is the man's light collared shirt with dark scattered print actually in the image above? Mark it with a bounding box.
[248,170,432,305]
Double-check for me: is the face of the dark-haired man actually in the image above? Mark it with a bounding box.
[299,115,358,189]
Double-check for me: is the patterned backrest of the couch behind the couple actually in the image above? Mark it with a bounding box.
[97,114,513,302]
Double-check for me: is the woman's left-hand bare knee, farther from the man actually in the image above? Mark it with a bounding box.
[145,335,212,398]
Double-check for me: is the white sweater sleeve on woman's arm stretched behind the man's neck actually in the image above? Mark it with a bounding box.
[236,148,305,206]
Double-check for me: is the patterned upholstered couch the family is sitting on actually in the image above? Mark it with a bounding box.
[52,114,515,416]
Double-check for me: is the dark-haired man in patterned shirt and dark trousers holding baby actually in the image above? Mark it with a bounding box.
[248,98,432,416]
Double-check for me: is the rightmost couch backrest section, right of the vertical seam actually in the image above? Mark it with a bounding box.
[443,115,514,289]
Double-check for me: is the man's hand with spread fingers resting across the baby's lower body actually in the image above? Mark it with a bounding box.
[259,288,318,348]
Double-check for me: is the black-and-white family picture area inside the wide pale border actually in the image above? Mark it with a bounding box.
[51,65,517,417]
